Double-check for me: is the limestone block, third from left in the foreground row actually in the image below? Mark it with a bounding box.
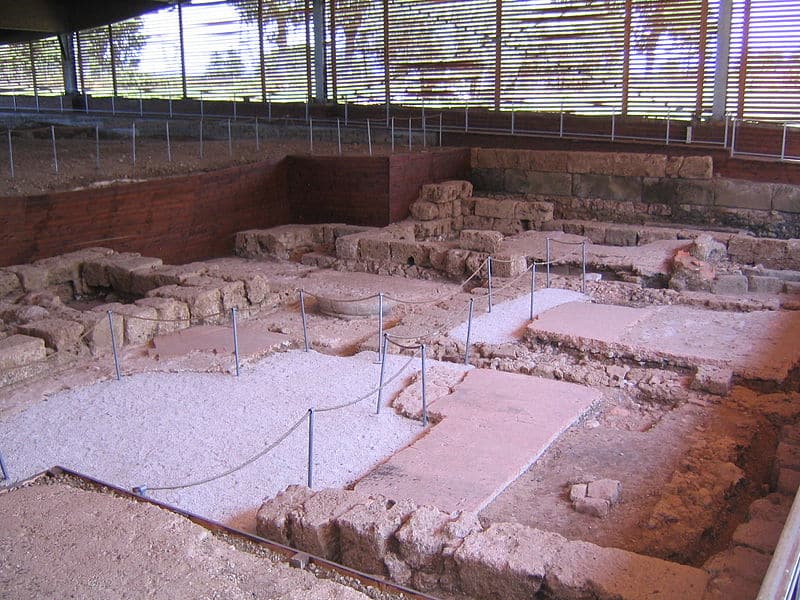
[336,497,416,575]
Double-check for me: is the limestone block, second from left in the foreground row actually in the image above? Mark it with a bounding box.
[289,489,364,560]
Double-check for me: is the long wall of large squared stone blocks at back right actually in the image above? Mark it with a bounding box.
[471,148,800,238]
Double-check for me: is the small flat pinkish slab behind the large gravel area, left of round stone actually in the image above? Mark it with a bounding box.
[148,322,290,358]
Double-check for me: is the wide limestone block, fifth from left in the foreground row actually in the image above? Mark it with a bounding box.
[454,523,552,600]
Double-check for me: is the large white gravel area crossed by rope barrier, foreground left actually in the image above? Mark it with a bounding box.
[0,351,435,529]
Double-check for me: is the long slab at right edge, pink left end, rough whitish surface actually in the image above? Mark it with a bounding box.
[525,302,800,382]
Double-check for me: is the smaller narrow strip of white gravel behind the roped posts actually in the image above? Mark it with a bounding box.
[450,288,589,344]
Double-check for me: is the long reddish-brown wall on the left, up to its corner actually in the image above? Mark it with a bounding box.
[0,161,289,265]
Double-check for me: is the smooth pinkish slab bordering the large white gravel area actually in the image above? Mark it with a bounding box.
[355,369,600,512]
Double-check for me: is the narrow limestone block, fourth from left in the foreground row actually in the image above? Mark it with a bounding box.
[395,506,454,571]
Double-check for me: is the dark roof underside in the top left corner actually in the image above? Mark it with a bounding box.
[0,0,176,43]
